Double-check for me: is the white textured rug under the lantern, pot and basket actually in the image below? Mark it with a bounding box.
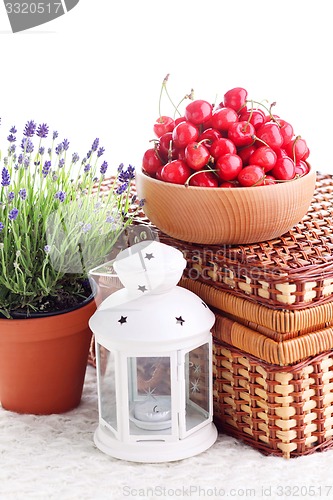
[0,366,333,500]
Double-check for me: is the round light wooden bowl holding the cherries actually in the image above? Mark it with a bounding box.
[136,168,316,245]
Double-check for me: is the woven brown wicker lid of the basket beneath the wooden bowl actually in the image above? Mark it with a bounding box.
[159,174,333,310]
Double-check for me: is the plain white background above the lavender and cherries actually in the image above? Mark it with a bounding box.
[0,0,333,172]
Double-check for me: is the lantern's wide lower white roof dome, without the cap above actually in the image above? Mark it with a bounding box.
[89,286,215,349]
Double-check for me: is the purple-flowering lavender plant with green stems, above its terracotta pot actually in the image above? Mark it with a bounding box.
[0,120,142,318]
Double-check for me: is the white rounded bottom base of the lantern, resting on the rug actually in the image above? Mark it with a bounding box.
[94,423,218,463]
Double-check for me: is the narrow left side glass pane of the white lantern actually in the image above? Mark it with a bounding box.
[97,344,117,430]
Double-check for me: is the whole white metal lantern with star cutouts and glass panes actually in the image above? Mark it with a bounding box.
[90,241,217,462]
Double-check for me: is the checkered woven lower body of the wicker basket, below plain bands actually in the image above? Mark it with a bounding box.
[214,342,333,458]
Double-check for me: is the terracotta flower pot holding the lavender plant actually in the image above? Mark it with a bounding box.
[0,299,96,415]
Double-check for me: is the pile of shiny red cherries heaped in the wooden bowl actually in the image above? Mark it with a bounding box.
[142,87,310,188]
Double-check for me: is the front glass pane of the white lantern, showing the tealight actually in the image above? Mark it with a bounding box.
[128,356,171,435]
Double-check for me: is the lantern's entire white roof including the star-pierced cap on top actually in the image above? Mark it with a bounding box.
[89,241,215,349]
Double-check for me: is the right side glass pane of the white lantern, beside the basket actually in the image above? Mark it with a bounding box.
[185,343,210,431]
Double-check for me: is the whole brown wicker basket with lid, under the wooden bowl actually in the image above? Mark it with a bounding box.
[91,174,333,458]
